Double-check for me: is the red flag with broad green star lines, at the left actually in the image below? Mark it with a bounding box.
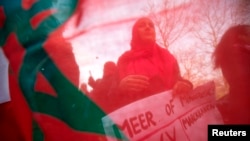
[0,0,126,141]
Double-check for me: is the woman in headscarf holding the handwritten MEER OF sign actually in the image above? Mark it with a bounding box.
[109,17,193,112]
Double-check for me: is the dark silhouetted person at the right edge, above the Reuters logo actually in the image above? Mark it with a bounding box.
[213,25,250,124]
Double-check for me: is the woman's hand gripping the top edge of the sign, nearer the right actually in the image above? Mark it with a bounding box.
[173,81,193,96]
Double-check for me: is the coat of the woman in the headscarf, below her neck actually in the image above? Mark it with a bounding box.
[110,45,182,107]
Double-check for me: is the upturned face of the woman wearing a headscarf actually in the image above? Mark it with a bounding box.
[136,18,155,43]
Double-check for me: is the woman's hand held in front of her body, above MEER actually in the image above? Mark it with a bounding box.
[119,75,149,92]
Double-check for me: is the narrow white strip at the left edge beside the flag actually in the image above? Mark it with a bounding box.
[0,48,10,104]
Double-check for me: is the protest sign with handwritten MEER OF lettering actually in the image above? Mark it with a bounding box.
[102,82,223,141]
